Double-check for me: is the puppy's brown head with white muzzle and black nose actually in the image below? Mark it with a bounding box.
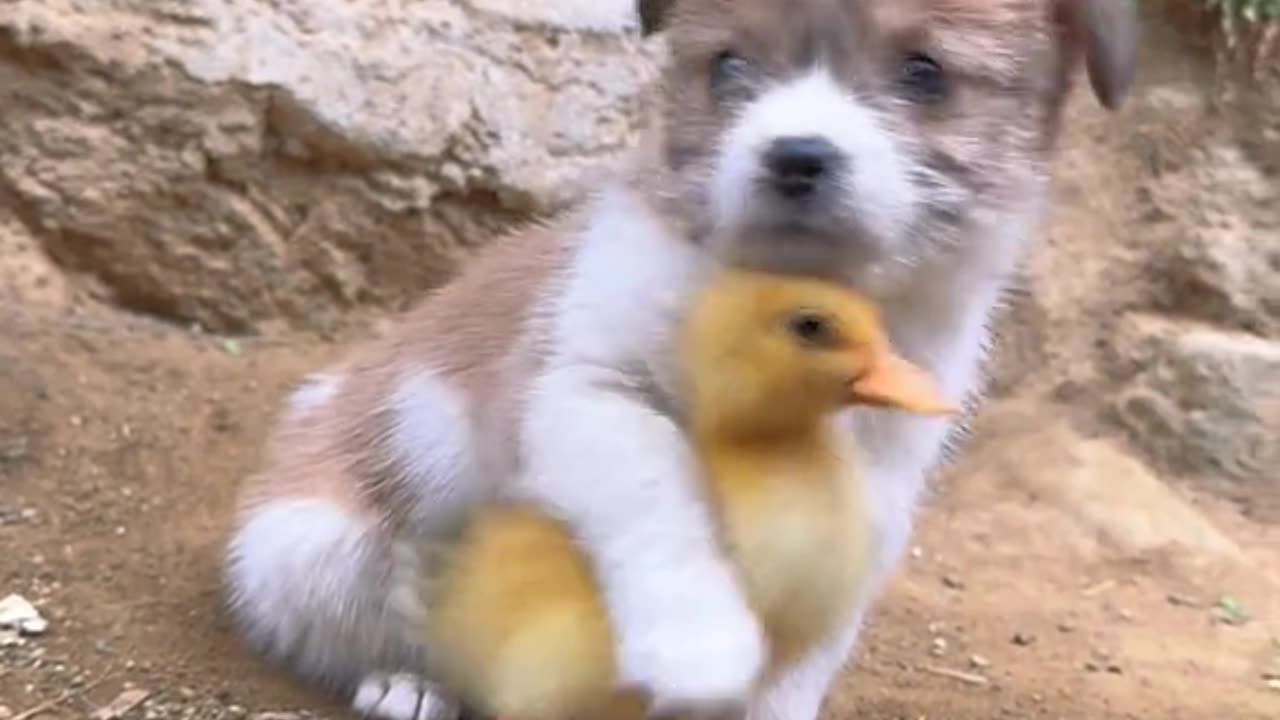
[639,0,1137,293]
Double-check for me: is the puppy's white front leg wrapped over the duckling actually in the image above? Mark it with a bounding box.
[518,366,764,714]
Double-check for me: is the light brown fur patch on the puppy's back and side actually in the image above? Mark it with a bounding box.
[234,210,581,532]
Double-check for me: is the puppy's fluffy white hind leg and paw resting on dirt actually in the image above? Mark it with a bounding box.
[224,497,457,720]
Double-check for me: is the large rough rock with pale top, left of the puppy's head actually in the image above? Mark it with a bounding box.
[0,0,654,332]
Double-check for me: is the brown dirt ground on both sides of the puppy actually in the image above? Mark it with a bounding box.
[0,14,1280,720]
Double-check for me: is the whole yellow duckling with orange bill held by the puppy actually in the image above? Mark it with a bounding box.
[414,270,952,720]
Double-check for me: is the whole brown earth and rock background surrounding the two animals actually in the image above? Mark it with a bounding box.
[0,0,1280,720]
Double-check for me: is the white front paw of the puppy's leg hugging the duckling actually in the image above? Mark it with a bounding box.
[623,603,765,716]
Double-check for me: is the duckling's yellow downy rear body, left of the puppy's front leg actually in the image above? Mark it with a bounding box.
[426,506,644,720]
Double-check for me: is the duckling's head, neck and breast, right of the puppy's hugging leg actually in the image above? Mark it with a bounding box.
[680,272,954,674]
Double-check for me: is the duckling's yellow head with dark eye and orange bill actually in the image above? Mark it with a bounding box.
[682,270,954,435]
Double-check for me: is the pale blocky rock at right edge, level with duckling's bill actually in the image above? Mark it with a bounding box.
[1114,315,1280,483]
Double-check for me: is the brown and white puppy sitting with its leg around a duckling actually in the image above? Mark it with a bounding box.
[227,0,1137,720]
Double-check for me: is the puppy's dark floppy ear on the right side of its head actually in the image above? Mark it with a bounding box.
[1055,0,1139,110]
